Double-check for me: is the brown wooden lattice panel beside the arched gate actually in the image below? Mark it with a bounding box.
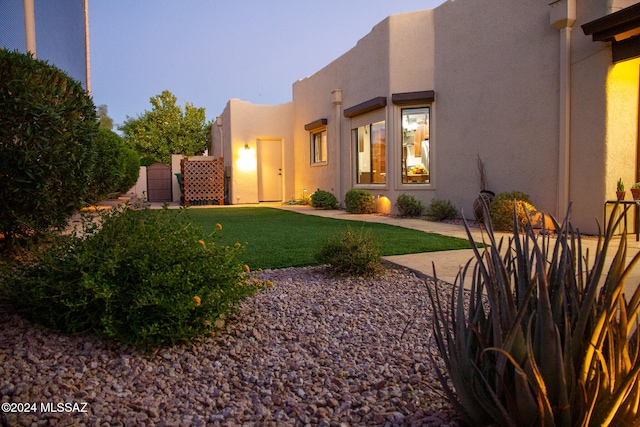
[180,157,224,205]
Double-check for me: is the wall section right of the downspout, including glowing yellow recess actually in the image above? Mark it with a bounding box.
[570,0,640,233]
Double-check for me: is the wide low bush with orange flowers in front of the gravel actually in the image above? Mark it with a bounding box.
[4,207,261,349]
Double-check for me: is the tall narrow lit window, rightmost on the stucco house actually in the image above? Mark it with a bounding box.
[400,107,431,184]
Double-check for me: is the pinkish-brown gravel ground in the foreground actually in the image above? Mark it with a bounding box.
[0,267,459,426]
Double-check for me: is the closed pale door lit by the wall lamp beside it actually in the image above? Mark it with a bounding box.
[257,139,282,202]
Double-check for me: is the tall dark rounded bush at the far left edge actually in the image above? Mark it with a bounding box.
[0,49,98,251]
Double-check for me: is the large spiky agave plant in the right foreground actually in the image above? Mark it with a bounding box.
[429,202,640,427]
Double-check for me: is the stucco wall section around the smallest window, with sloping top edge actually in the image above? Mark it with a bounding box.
[293,18,390,208]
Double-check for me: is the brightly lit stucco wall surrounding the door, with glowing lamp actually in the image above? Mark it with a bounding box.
[212,99,294,204]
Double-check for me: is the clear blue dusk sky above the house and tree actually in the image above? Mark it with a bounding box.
[89,0,453,130]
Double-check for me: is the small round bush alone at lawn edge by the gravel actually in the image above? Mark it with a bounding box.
[316,228,382,277]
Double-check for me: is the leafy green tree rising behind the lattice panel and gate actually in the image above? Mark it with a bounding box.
[119,90,209,165]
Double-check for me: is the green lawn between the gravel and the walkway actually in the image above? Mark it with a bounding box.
[189,207,471,269]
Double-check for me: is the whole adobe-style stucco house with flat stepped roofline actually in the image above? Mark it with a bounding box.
[212,0,640,232]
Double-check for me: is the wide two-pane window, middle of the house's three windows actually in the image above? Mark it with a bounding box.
[352,121,387,184]
